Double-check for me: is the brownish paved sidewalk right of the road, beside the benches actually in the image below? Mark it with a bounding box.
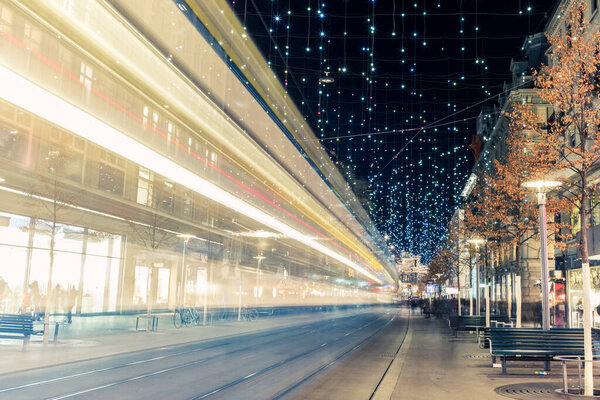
[386,316,598,400]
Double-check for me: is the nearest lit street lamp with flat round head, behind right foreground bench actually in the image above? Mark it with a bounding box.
[517,181,560,330]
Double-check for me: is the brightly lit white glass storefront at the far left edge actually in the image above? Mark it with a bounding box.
[0,209,121,313]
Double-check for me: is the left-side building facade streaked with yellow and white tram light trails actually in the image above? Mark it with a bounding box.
[0,0,396,314]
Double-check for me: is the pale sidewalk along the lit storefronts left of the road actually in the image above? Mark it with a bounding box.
[0,308,371,374]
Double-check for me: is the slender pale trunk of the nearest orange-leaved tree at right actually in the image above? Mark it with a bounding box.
[579,171,594,396]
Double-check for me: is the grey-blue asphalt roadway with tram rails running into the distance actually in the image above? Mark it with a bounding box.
[0,308,406,400]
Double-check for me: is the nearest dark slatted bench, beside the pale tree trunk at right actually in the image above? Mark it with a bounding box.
[489,327,600,374]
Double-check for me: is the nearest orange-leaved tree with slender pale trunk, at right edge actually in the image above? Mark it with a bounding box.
[512,0,600,396]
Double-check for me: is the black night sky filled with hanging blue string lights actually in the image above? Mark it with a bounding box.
[230,0,555,262]
